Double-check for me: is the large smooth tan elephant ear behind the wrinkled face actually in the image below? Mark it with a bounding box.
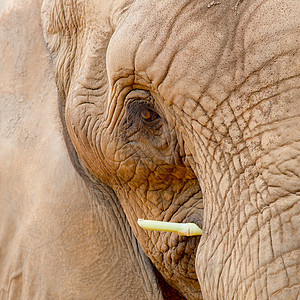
[0,0,162,299]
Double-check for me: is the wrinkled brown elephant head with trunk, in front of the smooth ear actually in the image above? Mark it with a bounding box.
[42,0,300,299]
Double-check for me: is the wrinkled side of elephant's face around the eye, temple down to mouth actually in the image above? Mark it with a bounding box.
[42,1,203,299]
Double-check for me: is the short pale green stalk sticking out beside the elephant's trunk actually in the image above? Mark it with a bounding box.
[137,219,202,236]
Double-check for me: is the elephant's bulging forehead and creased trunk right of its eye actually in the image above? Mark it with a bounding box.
[107,1,300,299]
